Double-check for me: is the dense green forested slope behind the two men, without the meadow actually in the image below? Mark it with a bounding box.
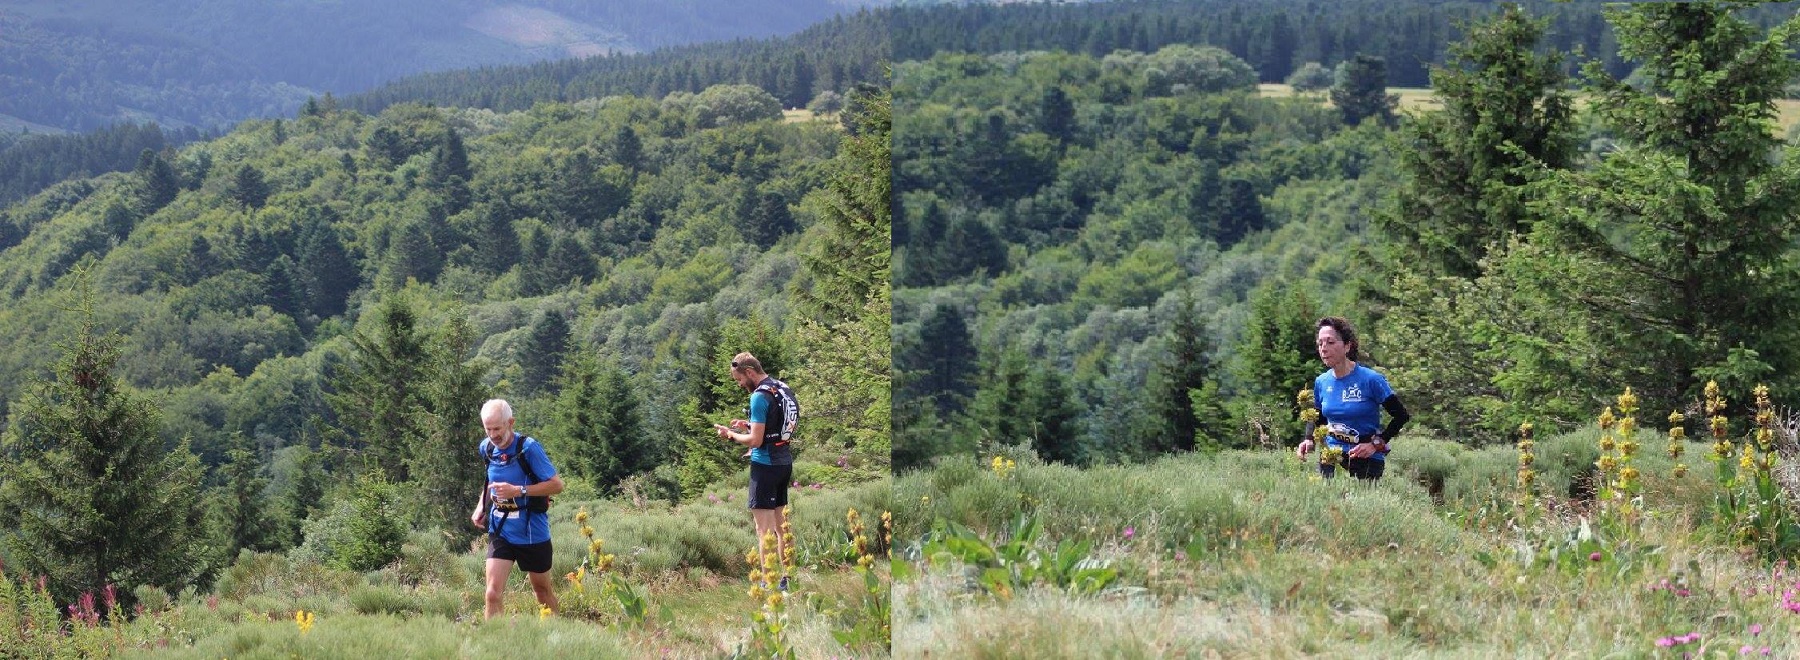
[0,73,889,602]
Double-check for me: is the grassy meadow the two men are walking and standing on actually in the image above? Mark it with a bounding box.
[0,478,891,658]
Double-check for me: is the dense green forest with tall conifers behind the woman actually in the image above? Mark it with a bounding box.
[895,4,1800,469]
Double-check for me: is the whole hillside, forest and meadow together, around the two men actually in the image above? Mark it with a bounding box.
[0,76,891,658]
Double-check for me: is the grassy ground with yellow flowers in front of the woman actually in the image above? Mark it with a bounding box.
[895,432,1800,658]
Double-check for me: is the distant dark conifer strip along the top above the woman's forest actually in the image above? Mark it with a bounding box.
[891,0,1793,86]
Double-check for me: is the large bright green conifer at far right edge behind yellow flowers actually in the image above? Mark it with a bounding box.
[1532,4,1800,419]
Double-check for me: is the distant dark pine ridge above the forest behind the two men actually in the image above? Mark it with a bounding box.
[0,4,887,230]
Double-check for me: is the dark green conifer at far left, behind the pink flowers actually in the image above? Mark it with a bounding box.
[0,273,207,602]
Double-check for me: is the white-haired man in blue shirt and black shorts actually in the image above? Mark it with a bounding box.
[468,399,563,619]
